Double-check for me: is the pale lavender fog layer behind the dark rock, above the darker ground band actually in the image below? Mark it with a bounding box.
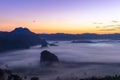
[0,41,120,67]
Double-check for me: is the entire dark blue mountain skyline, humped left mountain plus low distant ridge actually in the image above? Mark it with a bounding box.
[0,27,120,52]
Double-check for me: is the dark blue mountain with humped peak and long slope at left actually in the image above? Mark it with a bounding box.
[0,27,45,52]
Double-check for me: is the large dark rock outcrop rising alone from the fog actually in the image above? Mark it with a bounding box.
[40,50,59,62]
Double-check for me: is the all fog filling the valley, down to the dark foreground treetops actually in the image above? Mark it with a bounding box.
[0,41,120,80]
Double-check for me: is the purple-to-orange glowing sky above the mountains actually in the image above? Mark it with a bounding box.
[0,0,120,34]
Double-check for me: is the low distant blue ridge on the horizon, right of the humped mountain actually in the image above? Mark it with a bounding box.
[39,33,120,40]
